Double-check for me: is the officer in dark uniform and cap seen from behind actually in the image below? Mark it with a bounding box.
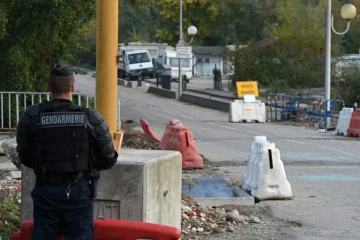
[16,61,118,240]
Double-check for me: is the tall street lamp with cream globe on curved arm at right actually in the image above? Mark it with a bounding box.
[324,0,357,132]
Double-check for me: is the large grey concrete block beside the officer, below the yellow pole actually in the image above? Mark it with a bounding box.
[21,149,182,229]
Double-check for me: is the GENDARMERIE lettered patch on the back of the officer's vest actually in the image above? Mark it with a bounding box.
[40,112,87,128]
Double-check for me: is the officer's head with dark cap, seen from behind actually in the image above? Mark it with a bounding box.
[48,60,75,94]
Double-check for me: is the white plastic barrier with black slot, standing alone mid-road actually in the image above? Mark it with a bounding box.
[242,136,292,200]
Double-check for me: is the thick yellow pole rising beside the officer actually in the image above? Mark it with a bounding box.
[96,0,119,137]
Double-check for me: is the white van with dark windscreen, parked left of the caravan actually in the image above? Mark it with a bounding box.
[118,49,154,80]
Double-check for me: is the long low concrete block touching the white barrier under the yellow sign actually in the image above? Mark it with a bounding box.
[180,93,230,112]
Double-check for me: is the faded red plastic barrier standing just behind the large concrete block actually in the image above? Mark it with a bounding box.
[159,119,204,169]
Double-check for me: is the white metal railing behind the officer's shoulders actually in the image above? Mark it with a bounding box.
[0,92,121,130]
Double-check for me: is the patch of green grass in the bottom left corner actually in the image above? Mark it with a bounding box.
[0,195,20,240]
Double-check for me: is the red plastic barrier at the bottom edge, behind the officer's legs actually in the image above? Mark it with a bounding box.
[12,219,181,240]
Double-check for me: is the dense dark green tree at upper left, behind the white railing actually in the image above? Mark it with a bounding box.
[0,0,95,91]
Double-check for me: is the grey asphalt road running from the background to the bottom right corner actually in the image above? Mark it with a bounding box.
[75,74,360,239]
